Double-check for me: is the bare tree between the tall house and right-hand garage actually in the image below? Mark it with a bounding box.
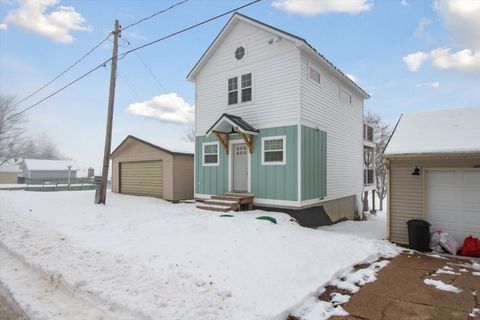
[365,111,391,211]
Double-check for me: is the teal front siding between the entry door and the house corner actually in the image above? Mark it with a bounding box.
[250,125,298,201]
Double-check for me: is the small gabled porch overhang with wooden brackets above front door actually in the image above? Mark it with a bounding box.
[206,113,259,154]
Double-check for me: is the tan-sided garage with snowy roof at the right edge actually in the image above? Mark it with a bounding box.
[384,108,480,243]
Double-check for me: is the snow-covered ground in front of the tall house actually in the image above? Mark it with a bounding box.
[0,191,398,319]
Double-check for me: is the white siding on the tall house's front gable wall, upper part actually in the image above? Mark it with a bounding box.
[195,22,300,136]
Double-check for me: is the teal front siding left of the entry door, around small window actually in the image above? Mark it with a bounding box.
[195,136,228,194]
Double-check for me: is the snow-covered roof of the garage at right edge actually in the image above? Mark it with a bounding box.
[384,108,480,155]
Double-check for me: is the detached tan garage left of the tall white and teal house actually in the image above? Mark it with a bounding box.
[111,136,193,201]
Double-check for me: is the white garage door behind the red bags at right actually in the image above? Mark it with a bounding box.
[425,170,480,243]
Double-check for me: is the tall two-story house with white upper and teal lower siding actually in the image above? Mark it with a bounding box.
[187,13,369,220]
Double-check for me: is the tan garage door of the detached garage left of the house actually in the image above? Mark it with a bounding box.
[120,160,163,198]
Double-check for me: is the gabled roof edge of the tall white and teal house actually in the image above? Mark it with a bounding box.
[187,12,370,99]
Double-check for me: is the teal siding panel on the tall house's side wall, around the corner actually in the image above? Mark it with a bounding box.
[301,126,327,200]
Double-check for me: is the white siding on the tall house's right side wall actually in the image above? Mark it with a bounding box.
[300,52,363,199]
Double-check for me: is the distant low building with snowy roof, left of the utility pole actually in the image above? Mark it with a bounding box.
[20,159,80,181]
